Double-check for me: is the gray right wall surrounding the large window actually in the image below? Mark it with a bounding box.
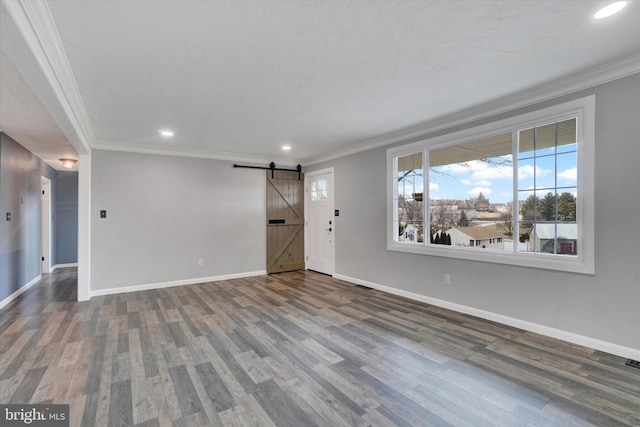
[306,74,640,349]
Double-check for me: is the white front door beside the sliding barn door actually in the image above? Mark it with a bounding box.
[305,168,335,275]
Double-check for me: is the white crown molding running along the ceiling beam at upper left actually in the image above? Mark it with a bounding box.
[2,0,93,153]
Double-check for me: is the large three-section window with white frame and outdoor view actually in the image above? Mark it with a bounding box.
[387,96,595,274]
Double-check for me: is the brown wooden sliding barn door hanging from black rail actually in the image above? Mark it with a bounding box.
[267,171,304,274]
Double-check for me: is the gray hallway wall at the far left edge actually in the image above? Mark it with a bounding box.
[0,133,56,301]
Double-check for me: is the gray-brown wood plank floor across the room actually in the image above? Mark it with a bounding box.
[0,269,640,427]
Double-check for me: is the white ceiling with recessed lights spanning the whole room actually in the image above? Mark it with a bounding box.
[0,0,640,169]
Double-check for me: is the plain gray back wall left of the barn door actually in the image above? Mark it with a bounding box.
[91,150,266,291]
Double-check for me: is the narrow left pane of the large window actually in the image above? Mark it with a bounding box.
[394,152,424,243]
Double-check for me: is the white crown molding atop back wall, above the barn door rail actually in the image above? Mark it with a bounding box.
[92,140,300,167]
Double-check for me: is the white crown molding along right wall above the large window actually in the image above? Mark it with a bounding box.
[303,53,640,166]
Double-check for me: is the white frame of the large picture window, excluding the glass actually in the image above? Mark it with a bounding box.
[387,95,595,274]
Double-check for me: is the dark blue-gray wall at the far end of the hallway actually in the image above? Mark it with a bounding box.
[52,171,78,264]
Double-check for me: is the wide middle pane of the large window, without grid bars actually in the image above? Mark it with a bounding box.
[429,132,513,250]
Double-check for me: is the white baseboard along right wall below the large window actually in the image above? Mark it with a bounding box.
[333,274,640,360]
